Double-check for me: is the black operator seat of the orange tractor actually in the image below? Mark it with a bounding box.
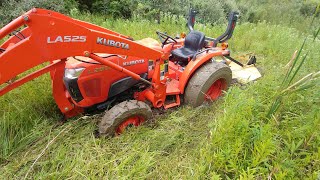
[171,31,205,62]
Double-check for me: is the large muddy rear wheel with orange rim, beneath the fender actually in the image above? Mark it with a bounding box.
[184,62,232,107]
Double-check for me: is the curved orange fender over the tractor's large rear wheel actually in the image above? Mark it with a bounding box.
[179,50,225,94]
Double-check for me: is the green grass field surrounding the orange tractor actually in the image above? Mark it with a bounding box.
[0,15,320,179]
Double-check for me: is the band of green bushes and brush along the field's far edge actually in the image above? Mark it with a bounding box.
[0,0,320,32]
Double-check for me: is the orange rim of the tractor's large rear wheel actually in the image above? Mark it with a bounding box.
[205,78,227,101]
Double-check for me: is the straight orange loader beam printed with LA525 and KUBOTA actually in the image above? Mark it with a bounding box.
[0,9,163,89]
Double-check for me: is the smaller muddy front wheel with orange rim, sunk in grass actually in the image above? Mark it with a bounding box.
[99,100,152,136]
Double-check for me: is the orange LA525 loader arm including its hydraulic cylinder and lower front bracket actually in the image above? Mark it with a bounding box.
[0,9,168,118]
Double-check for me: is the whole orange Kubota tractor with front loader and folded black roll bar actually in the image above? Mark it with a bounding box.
[0,9,260,135]
